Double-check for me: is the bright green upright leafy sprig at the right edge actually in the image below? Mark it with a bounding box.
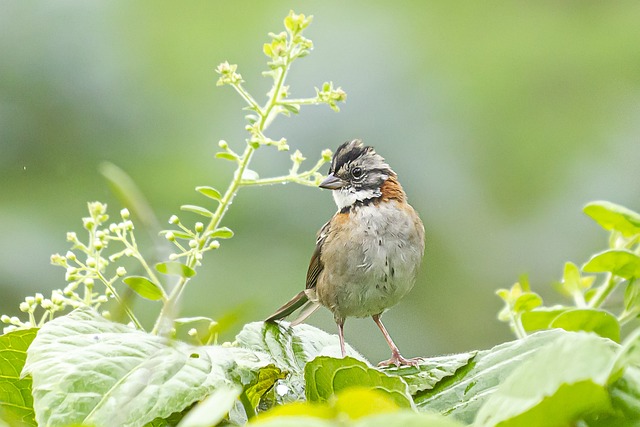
[497,201,640,341]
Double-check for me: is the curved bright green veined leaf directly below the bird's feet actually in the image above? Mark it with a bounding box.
[304,356,413,408]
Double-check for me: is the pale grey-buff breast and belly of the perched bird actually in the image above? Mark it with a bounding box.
[317,204,424,319]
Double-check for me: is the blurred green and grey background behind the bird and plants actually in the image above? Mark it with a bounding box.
[0,0,640,360]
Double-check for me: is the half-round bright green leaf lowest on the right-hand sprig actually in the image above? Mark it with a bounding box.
[549,308,620,342]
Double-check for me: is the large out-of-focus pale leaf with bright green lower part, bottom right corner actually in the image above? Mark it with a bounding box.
[475,333,617,427]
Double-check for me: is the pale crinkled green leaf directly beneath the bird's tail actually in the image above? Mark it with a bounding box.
[236,322,364,403]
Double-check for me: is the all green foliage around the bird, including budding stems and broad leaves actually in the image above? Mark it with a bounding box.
[0,8,640,427]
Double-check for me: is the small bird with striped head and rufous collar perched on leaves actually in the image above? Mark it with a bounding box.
[265,139,425,367]
